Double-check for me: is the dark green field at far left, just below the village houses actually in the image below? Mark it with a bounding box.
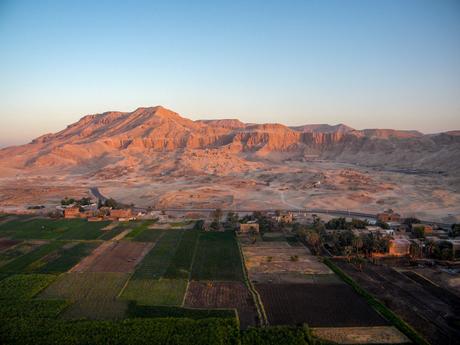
[0,218,109,240]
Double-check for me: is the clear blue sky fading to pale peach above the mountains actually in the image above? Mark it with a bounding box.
[0,0,460,146]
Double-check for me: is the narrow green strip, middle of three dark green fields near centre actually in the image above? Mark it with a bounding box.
[164,230,200,279]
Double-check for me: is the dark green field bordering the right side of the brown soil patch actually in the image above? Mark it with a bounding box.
[133,230,183,279]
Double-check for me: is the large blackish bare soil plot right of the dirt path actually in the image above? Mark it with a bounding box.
[255,283,388,327]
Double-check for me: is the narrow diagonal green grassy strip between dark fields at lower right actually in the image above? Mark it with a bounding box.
[324,258,429,345]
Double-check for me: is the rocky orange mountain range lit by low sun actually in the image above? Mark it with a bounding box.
[0,106,460,174]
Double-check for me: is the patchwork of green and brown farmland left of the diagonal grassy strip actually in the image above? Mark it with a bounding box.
[0,217,416,344]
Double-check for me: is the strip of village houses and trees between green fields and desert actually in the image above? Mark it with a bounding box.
[54,198,460,261]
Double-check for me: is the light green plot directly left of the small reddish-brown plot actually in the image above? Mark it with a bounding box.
[121,279,187,306]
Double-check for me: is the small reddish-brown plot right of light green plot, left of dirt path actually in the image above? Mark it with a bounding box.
[184,282,258,329]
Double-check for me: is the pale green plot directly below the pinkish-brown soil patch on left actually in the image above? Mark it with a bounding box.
[39,272,129,319]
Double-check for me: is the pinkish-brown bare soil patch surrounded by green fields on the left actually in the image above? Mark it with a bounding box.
[71,241,153,273]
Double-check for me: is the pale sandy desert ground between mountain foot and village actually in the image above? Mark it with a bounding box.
[0,161,460,222]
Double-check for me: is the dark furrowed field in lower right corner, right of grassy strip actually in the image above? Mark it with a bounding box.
[334,260,460,344]
